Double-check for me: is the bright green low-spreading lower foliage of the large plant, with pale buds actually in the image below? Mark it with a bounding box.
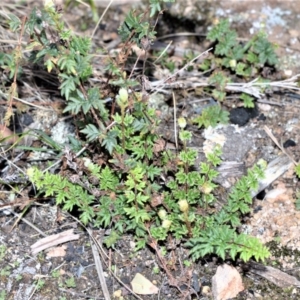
[27,125,269,261]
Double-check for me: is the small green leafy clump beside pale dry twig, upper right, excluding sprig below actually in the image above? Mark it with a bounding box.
[200,20,278,107]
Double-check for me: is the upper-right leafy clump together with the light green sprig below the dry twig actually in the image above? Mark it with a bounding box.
[193,20,278,128]
